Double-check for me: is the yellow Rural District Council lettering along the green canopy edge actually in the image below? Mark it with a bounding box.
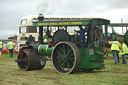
[38,21,83,26]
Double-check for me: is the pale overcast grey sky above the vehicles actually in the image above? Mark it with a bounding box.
[0,0,128,39]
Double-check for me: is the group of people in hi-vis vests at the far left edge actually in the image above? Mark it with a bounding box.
[0,40,16,57]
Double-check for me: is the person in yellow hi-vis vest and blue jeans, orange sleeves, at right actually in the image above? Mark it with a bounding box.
[109,38,123,64]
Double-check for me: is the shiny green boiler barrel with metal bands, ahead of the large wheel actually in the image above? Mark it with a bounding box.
[38,44,53,56]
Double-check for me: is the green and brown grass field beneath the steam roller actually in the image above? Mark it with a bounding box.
[0,54,128,85]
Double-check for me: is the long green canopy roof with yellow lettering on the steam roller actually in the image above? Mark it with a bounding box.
[33,18,110,26]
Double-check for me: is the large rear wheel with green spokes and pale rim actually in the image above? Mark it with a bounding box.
[51,41,81,74]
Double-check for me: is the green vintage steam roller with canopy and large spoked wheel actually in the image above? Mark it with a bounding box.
[15,15,110,74]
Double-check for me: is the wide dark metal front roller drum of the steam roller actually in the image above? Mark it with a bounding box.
[16,49,46,71]
